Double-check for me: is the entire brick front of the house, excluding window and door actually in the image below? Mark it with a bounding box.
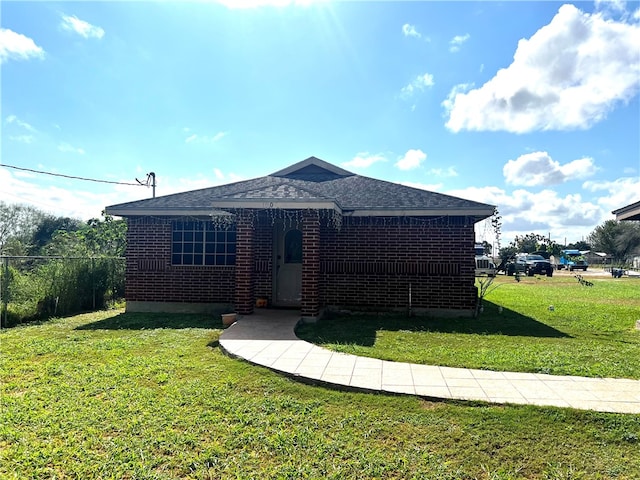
[126,215,477,316]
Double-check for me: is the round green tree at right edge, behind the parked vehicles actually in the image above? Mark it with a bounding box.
[587,220,640,263]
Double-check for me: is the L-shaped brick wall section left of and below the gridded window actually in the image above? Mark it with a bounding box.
[125,218,235,303]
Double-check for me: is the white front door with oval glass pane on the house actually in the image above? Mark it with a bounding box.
[273,224,302,306]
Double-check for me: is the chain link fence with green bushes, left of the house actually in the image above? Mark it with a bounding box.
[0,256,125,327]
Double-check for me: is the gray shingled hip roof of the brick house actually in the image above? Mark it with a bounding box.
[107,157,494,220]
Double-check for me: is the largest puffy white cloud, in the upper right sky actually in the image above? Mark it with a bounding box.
[443,5,640,133]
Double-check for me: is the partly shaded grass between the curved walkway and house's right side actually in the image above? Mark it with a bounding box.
[298,275,640,379]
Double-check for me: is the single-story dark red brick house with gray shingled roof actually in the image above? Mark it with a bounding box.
[106,157,494,319]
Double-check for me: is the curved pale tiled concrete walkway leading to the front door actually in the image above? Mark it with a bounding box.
[220,310,640,414]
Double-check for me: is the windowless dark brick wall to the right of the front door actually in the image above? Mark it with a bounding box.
[320,218,477,310]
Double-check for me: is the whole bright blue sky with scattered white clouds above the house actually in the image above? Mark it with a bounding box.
[0,0,640,245]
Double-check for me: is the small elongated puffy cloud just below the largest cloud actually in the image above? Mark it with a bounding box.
[502,152,596,187]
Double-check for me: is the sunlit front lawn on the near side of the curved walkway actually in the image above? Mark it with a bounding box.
[0,304,640,479]
